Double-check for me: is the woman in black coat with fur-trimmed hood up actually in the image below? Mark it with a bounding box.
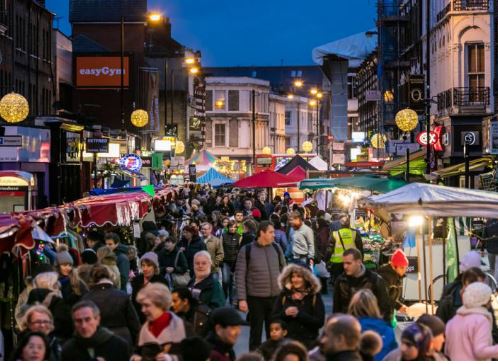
[272,264,325,349]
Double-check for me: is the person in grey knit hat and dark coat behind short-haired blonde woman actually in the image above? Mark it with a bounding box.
[131,252,168,323]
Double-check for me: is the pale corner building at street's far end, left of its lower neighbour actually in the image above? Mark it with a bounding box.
[205,77,271,169]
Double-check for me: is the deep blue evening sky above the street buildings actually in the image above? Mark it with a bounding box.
[47,0,376,66]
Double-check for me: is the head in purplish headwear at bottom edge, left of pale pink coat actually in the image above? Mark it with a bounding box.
[400,323,432,361]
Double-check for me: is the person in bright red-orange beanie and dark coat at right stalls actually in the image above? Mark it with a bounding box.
[377,249,408,313]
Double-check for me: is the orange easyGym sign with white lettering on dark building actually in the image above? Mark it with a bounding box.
[75,56,129,87]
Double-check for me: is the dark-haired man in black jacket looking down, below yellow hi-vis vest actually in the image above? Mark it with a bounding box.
[333,248,392,322]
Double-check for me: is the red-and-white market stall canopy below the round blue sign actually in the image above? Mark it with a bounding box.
[64,192,151,227]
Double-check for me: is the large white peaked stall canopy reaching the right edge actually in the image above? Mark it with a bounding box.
[363,183,498,218]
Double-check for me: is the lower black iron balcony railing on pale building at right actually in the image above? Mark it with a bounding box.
[437,87,490,114]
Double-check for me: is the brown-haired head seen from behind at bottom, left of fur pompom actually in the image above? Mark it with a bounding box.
[321,314,361,355]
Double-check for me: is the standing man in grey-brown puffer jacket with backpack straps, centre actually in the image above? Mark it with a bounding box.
[235,221,285,351]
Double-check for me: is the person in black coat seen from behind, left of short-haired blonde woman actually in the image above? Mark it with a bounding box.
[83,265,140,346]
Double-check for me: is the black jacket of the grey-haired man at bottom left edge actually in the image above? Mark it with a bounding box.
[61,327,131,361]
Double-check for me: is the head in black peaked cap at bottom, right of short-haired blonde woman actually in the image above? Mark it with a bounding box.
[210,307,247,346]
